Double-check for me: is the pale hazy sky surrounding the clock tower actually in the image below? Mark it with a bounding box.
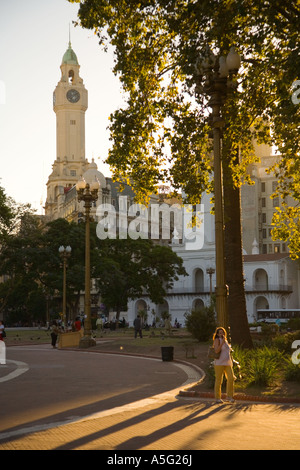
[0,0,123,214]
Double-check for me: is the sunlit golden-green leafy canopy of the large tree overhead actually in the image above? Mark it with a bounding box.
[69,0,300,251]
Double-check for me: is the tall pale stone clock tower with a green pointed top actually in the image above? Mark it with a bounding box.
[45,42,89,219]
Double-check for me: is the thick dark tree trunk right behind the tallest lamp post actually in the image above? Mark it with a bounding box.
[223,151,253,348]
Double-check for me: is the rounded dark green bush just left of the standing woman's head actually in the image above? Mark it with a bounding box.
[184,305,217,341]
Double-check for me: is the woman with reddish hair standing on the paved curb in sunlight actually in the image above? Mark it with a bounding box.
[213,327,234,403]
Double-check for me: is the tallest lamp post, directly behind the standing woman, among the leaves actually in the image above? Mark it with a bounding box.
[196,47,240,328]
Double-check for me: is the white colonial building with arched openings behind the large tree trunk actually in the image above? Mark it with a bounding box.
[128,189,300,324]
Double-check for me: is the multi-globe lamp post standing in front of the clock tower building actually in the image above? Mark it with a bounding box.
[76,180,100,348]
